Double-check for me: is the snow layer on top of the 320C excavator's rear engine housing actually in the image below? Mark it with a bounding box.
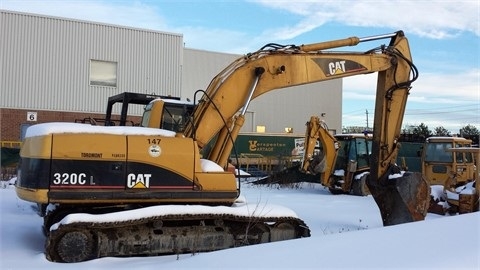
[25,122,175,138]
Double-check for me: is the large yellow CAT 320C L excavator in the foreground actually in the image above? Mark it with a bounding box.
[16,31,429,262]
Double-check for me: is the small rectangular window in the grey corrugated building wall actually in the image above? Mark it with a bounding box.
[90,60,117,87]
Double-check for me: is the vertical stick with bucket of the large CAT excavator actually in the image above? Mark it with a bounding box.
[367,34,430,225]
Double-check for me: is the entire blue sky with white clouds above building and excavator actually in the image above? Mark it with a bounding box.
[0,0,480,133]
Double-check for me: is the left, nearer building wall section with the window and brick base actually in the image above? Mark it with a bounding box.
[0,10,183,141]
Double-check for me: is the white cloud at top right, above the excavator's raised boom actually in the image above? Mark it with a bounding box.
[254,0,480,39]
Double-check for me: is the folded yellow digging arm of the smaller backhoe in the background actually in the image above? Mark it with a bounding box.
[300,116,339,185]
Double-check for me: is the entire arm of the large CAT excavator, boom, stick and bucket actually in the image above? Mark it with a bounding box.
[184,31,429,225]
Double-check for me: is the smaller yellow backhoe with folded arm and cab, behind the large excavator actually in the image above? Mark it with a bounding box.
[302,116,372,196]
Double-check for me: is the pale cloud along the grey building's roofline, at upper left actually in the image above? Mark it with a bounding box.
[0,0,259,54]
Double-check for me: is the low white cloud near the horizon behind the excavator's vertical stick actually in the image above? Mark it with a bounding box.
[342,69,480,133]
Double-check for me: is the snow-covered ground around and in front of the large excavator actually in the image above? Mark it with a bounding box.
[0,177,480,270]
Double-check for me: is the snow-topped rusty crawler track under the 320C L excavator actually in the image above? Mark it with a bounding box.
[46,206,310,263]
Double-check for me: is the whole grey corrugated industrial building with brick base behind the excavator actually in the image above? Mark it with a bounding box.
[0,10,342,147]
